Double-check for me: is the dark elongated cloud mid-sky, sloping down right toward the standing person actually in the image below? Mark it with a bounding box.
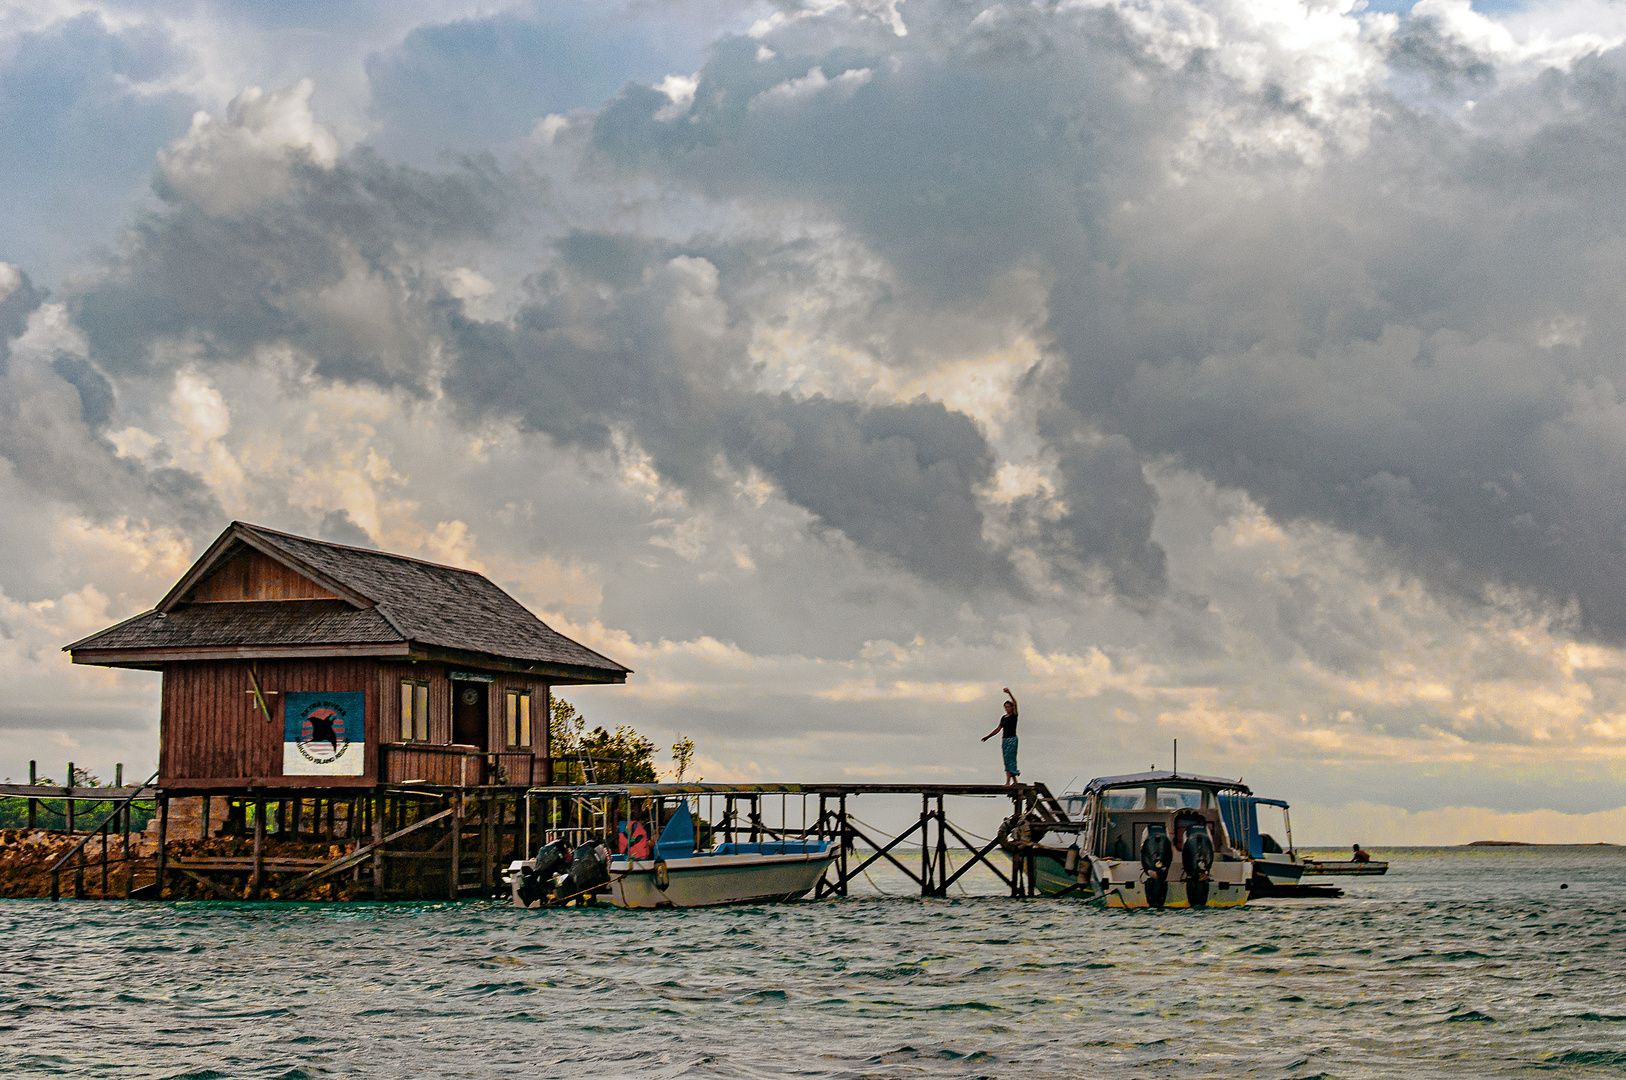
[442,243,1016,587]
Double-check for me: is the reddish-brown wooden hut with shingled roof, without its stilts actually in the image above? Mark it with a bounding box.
[65,522,631,794]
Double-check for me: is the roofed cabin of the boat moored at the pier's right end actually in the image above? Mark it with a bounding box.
[1062,771,1250,860]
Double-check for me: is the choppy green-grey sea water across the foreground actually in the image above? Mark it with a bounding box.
[0,847,1626,1080]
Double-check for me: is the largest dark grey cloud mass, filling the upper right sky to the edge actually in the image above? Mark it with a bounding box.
[595,3,1626,636]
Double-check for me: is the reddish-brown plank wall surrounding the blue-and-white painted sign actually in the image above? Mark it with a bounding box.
[158,659,380,787]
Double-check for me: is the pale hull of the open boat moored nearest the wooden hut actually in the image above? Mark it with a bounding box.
[608,851,837,908]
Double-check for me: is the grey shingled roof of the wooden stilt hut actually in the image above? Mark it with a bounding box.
[67,522,631,682]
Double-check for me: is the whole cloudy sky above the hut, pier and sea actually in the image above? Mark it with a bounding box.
[9,0,1626,843]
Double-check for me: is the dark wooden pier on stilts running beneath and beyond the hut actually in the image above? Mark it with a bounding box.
[12,784,1054,901]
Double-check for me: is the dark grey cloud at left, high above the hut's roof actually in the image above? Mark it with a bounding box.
[70,150,507,390]
